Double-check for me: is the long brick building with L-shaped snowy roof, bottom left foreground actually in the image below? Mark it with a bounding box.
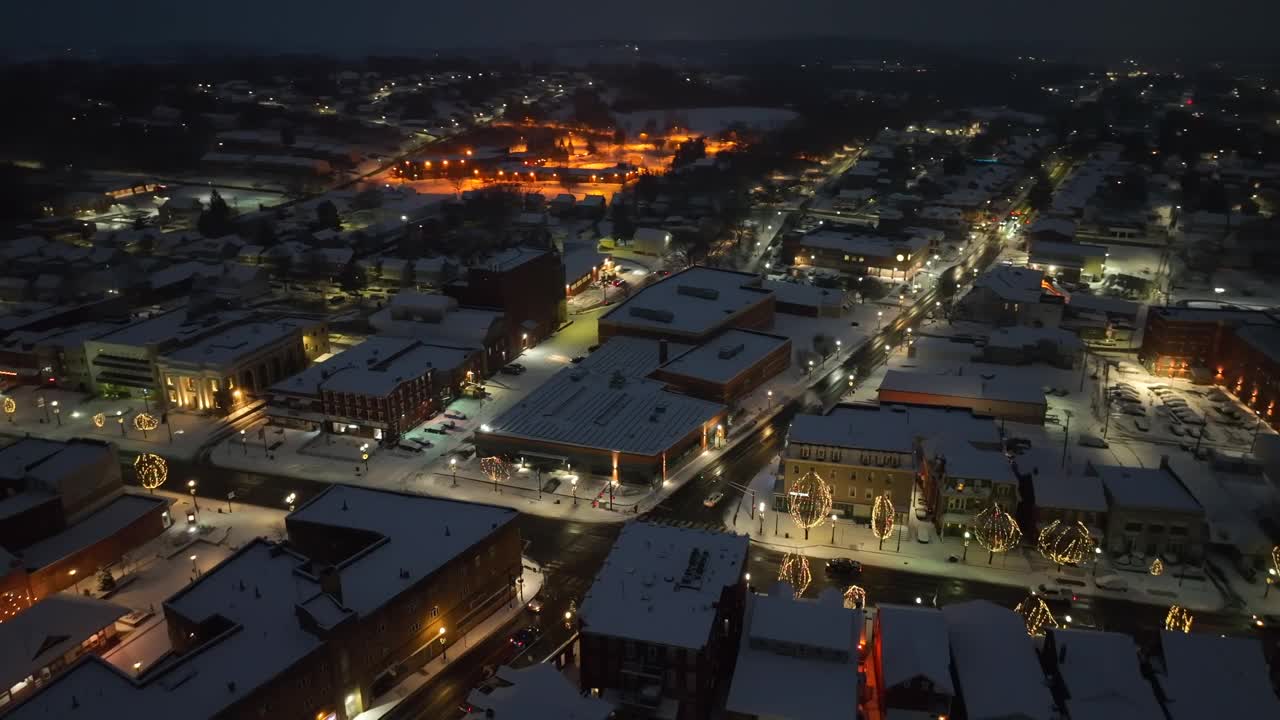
[1,486,519,720]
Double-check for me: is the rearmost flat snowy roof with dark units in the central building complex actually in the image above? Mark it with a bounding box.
[600,266,773,337]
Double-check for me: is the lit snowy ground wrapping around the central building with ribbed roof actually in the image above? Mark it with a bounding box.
[210,297,900,523]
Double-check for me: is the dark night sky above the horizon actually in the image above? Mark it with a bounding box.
[0,0,1280,55]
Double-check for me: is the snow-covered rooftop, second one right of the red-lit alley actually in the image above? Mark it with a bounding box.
[942,600,1055,720]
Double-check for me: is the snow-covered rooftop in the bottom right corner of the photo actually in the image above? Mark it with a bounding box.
[1156,630,1280,720]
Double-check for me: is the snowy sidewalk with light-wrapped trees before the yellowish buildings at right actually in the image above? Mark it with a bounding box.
[724,466,1223,611]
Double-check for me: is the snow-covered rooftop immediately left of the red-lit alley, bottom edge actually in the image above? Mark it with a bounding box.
[724,585,863,720]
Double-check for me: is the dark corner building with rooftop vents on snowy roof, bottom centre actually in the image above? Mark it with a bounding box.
[579,521,748,720]
